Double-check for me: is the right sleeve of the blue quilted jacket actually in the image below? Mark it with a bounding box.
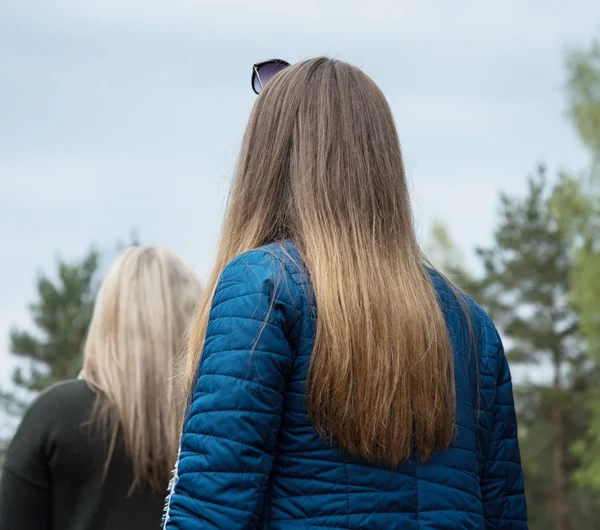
[481,329,528,530]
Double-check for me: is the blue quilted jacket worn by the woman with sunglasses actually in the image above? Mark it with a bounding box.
[165,243,527,530]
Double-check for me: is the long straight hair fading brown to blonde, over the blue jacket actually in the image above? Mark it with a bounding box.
[187,58,456,465]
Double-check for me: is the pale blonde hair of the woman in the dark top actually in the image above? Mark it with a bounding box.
[81,247,200,493]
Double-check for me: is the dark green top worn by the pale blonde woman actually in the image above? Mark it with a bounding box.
[0,380,166,530]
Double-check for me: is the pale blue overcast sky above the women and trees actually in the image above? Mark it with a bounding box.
[0,0,600,382]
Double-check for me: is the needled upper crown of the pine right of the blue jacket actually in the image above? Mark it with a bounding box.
[477,168,582,369]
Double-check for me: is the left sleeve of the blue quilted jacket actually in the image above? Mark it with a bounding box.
[165,250,302,530]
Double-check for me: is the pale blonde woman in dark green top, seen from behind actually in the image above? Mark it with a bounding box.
[0,247,200,530]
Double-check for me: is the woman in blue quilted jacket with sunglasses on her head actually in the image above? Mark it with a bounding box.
[165,58,527,530]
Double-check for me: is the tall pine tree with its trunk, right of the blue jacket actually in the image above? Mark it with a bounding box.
[478,168,598,530]
